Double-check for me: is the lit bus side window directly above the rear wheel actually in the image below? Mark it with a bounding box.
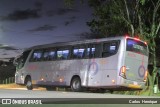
[73,47,85,58]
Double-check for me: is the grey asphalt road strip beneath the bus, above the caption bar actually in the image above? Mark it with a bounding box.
[0,89,156,98]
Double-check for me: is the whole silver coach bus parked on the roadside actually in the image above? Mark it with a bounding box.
[15,36,148,92]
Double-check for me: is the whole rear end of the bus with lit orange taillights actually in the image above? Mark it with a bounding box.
[119,37,148,89]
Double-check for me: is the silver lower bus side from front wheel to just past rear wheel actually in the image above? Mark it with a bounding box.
[27,59,88,86]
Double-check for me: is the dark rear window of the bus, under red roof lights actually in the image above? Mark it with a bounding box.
[126,38,148,56]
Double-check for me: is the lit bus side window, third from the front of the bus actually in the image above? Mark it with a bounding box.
[57,49,69,59]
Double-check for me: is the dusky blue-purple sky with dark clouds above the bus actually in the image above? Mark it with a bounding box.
[0,0,92,48]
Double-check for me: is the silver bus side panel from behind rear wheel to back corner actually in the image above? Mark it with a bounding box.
[85,39,125,88]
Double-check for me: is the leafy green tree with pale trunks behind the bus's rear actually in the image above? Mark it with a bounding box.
[65,0,160,94]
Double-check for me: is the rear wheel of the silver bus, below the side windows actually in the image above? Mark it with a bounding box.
[71,77,82,92]
